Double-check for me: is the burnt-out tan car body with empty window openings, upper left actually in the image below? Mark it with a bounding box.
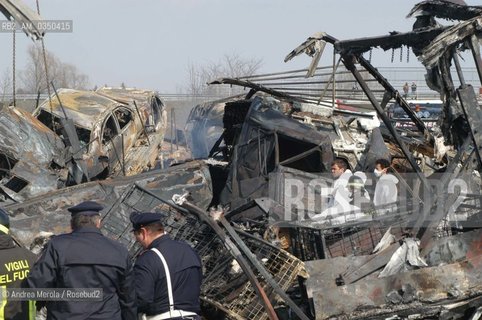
[33,88,166,184]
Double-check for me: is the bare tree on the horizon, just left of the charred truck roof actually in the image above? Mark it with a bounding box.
[186,53,262,95]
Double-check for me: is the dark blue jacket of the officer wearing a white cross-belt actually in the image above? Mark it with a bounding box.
[134,235,202,315]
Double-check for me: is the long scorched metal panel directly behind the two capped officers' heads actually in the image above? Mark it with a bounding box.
[5,161,212,248]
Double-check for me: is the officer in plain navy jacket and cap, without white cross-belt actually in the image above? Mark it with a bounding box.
[27,201,137,320]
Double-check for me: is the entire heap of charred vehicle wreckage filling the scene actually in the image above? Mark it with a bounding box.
[0,1,482,319]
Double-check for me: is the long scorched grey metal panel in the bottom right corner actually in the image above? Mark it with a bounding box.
[313,257,482,319]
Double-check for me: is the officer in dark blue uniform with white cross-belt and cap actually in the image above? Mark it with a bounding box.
[130,212,202,320]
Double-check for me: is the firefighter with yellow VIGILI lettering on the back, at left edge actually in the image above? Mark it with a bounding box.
[0,209,37,320]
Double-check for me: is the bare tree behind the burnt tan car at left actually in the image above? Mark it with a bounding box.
[20,45,89,93]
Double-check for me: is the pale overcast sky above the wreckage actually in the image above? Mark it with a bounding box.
[0,0,480,93]
